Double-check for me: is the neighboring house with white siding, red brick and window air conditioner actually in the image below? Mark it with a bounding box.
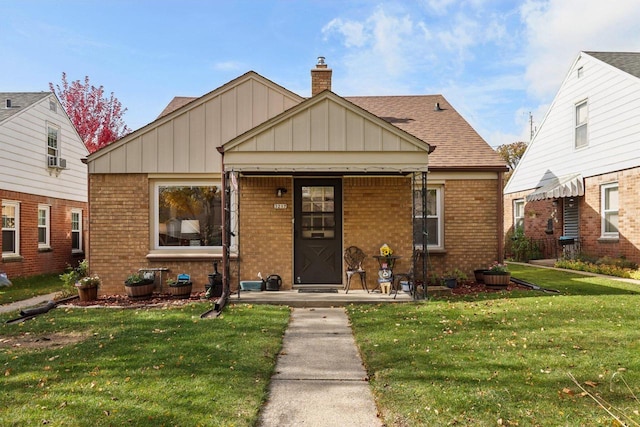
[0,92,89,278]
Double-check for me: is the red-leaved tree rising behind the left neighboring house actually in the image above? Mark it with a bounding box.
[49,73,131,153]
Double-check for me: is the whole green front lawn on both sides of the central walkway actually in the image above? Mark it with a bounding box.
[0,266,640,426]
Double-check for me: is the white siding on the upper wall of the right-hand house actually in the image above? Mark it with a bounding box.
[505,53,640,194]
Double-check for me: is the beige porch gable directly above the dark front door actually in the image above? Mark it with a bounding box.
[222,90,430,172]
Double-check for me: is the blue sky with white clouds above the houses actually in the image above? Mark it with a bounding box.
[0,0,640,147]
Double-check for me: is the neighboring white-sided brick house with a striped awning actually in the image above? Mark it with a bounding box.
[504,52,640,263]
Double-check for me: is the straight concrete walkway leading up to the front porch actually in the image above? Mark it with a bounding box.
[258,308,383,427]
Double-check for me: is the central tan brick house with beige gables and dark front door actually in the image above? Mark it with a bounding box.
[88,58,507,293]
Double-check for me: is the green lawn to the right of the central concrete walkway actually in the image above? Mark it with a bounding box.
[348,266,640,426]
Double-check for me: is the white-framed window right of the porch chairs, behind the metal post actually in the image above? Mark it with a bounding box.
[413,187,444,248]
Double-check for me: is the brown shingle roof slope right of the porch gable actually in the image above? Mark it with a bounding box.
[345,95,506,170]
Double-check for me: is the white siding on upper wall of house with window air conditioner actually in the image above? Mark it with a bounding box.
[0,94,89,202]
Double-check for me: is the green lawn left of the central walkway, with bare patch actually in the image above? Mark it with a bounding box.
[0,303,289,426]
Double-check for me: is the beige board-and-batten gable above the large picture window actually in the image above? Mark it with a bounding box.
[89,72,303,173]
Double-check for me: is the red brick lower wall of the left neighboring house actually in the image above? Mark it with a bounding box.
[0,190,88,278]
